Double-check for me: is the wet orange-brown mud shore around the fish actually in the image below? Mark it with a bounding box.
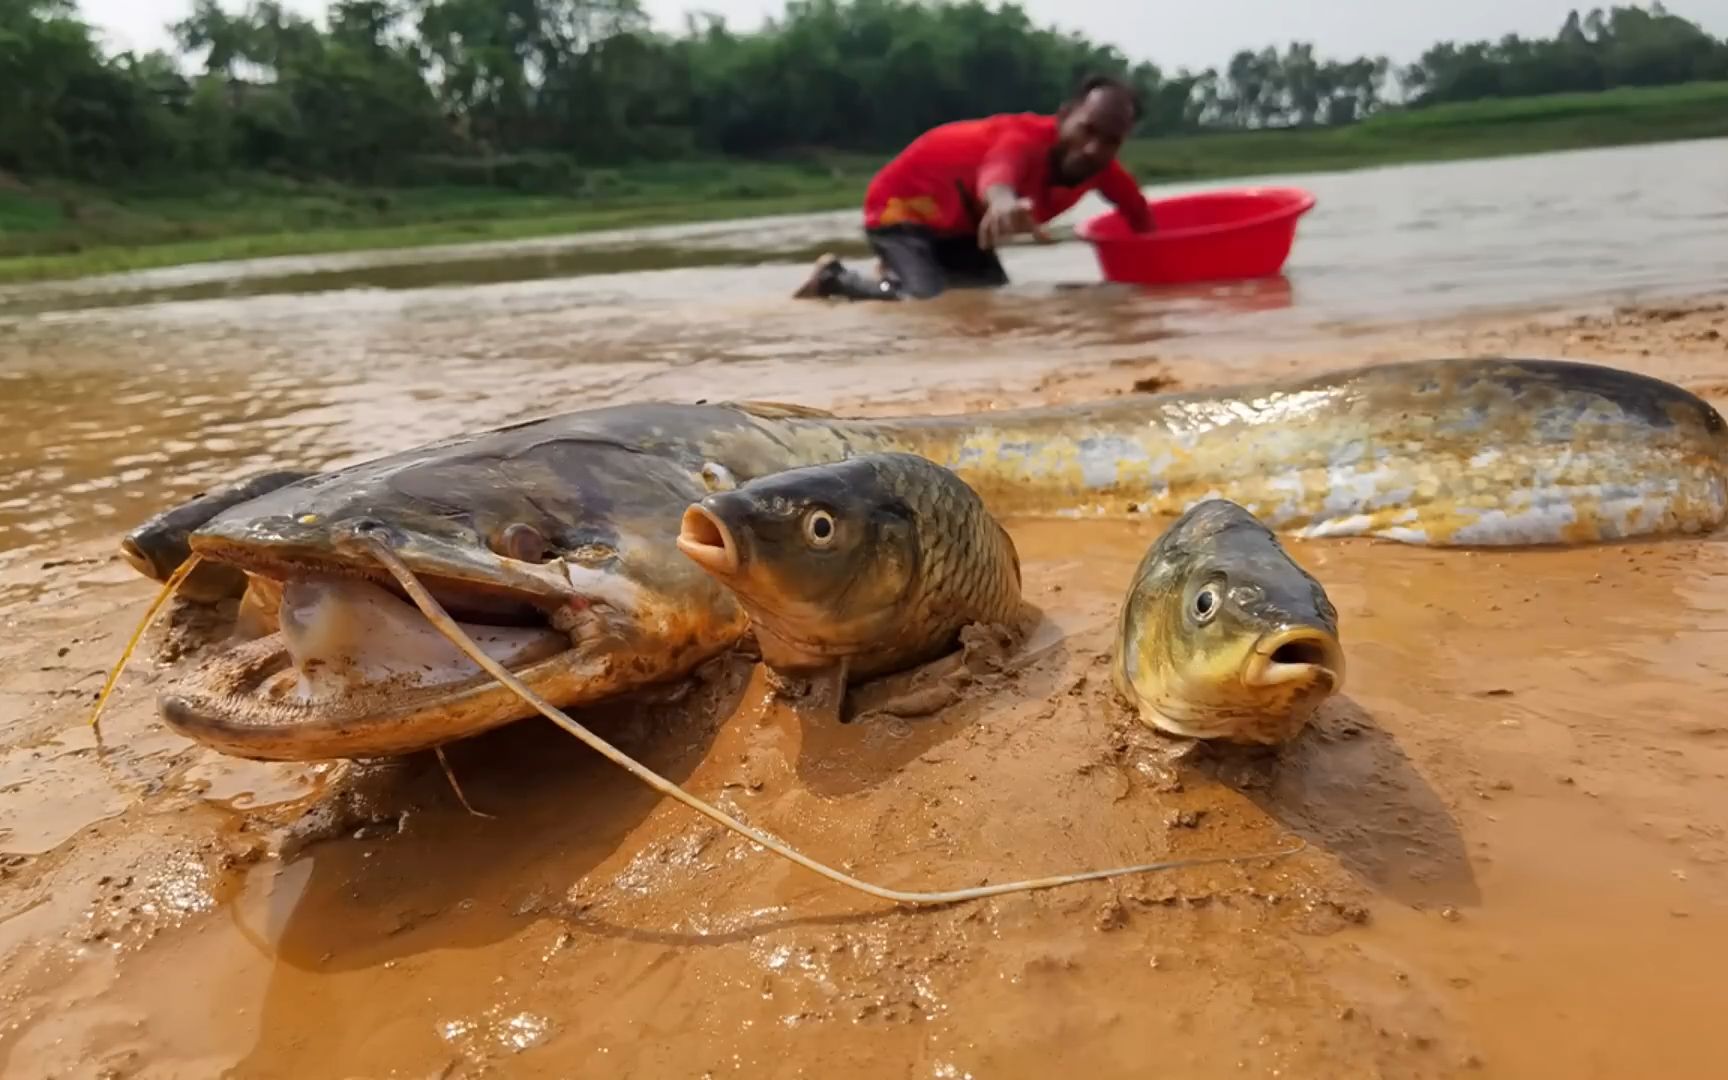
[0,299,1728,1080]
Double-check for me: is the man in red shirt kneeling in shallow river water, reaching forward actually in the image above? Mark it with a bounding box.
[795,76,1153,301]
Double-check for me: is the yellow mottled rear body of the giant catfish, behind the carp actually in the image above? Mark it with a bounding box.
[839,359,1728,546]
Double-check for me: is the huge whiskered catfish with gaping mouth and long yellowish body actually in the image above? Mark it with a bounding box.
[145,359,1728,759]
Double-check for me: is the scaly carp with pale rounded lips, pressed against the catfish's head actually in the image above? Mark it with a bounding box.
[677,453,1020,679]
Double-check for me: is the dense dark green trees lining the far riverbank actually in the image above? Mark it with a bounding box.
[0,0,1728,187]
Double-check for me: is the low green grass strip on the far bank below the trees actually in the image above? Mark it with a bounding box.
[0,83,1728,282]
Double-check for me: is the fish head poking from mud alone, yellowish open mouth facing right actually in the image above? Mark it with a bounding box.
[1111,499,1344,745]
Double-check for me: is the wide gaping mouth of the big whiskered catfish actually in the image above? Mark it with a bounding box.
[159,534,622,760]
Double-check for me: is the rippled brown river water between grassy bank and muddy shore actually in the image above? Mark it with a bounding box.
[0,140,1728,603]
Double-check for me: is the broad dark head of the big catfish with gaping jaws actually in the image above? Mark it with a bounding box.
[161,427,746,760]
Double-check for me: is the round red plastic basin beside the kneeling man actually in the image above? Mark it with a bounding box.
[1075,188,1315,285]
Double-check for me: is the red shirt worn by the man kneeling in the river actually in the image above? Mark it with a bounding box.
[864,112,1151,233]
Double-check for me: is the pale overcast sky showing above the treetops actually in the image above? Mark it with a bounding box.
[79,0,1728,69]
